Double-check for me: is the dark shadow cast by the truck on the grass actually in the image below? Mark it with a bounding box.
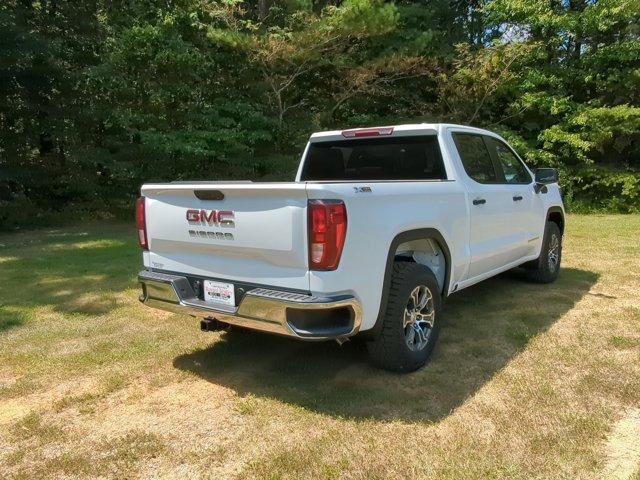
[174,268,598,421]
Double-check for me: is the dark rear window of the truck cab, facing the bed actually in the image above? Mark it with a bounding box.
[301,135,447,181]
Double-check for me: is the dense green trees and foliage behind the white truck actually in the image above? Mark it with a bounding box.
[0,0,640,228]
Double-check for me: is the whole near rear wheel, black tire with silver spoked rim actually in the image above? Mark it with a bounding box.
[367,262,442,372]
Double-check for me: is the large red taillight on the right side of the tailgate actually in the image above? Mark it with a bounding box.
[308,200,347,270]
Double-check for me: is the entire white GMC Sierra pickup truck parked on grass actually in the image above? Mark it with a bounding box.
[136,124,564,371]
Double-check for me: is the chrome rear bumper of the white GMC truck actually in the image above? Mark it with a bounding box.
[138,270,362,340]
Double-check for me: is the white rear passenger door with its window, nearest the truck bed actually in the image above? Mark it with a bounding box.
[452,132,521,279]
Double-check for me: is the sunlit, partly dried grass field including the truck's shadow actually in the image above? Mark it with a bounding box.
[0,216,640,479]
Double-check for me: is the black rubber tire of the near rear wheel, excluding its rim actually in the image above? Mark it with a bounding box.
[367,262,442,372]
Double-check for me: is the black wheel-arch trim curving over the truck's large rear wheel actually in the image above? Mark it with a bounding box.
[363,228,451,336]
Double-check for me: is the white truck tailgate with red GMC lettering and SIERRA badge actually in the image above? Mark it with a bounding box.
[142,182,309,290]
